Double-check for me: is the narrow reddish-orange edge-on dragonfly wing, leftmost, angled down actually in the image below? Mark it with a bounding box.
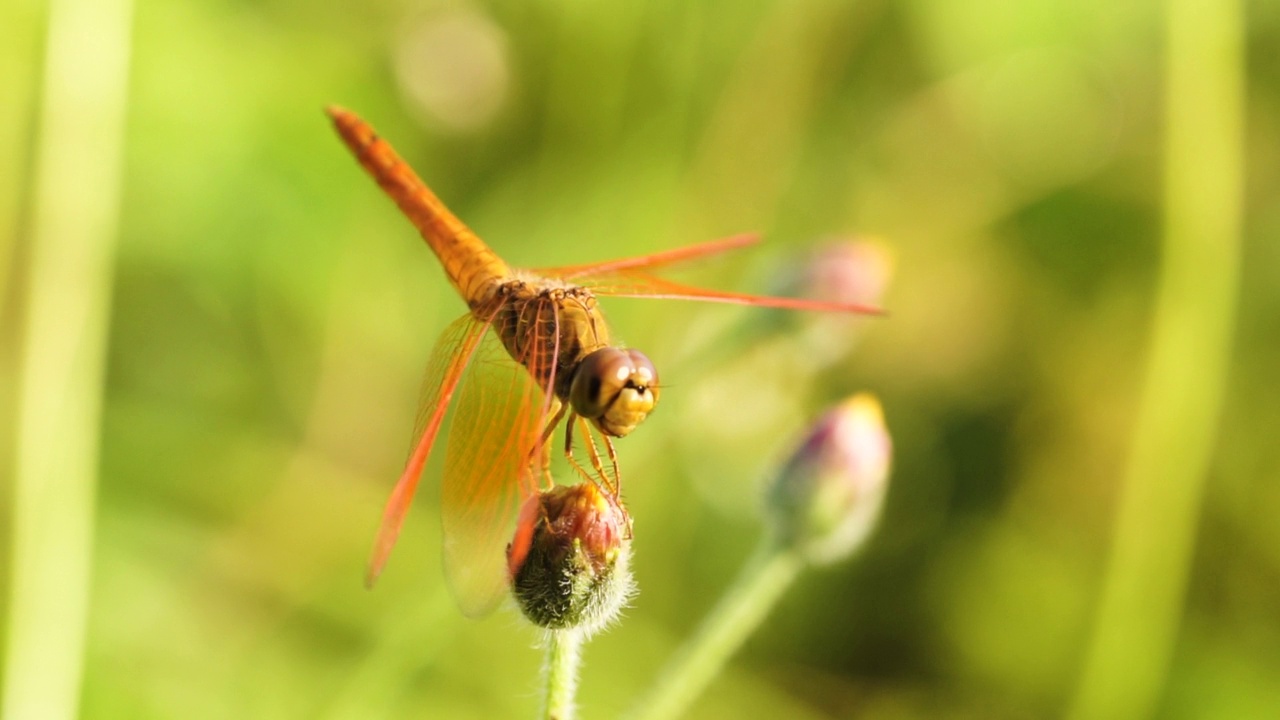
[365,314,489,587]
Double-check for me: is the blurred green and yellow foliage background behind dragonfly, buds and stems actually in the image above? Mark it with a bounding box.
[0,0,1280,720]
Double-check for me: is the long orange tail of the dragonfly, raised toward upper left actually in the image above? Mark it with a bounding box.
[325,105,511,307]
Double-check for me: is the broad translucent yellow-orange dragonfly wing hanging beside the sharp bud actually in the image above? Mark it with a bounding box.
[440,319,548,616]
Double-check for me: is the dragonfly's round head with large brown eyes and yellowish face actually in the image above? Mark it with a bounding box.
[568,347,658,437]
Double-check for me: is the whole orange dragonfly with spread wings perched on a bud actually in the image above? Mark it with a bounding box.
[326,106,879,616]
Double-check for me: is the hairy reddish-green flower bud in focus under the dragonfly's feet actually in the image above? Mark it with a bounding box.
[507,483,635,633]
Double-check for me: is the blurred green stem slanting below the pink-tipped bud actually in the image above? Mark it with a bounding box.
[630,542,804,720]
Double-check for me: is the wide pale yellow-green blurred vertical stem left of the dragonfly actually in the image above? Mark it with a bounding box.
[0,0,132,720]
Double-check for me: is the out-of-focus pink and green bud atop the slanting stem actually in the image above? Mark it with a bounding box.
[767,393,892,562]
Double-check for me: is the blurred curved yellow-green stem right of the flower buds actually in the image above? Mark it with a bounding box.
[1070,0,1244,719]
